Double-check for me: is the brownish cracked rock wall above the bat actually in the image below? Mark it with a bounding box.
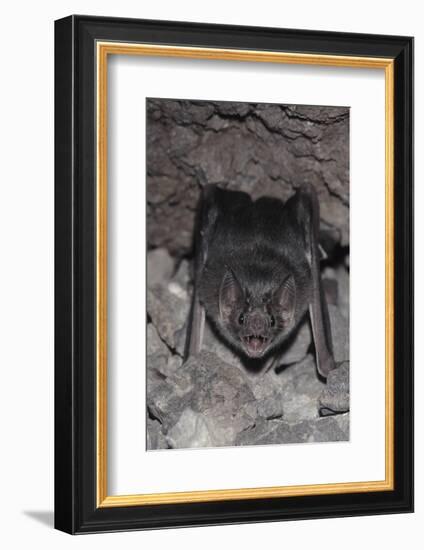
[147,99,349,256]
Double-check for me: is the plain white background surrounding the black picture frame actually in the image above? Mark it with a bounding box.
[0,0,418,550]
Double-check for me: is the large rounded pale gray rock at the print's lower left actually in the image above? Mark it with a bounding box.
[147,351,257,448]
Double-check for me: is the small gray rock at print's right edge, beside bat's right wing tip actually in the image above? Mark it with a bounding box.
[319,361,349,416]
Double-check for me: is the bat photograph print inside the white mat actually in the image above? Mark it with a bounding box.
[146,97,350,451]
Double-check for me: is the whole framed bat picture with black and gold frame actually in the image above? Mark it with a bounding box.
[55,16,413,534]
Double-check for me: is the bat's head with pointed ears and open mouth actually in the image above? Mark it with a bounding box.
[219,269,296,359]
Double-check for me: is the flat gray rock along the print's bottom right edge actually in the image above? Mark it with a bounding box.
[235,413,349,445]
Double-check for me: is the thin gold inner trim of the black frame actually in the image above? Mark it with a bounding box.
[96,41,394,507]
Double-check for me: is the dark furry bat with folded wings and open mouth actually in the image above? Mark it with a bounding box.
[186,185,335,378]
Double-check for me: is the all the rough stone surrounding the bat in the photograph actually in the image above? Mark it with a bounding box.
[147,99,349,449]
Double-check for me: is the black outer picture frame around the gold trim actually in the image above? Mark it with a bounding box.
[55,15,413,534]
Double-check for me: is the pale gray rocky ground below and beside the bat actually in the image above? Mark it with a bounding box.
[147,249,349,450]
